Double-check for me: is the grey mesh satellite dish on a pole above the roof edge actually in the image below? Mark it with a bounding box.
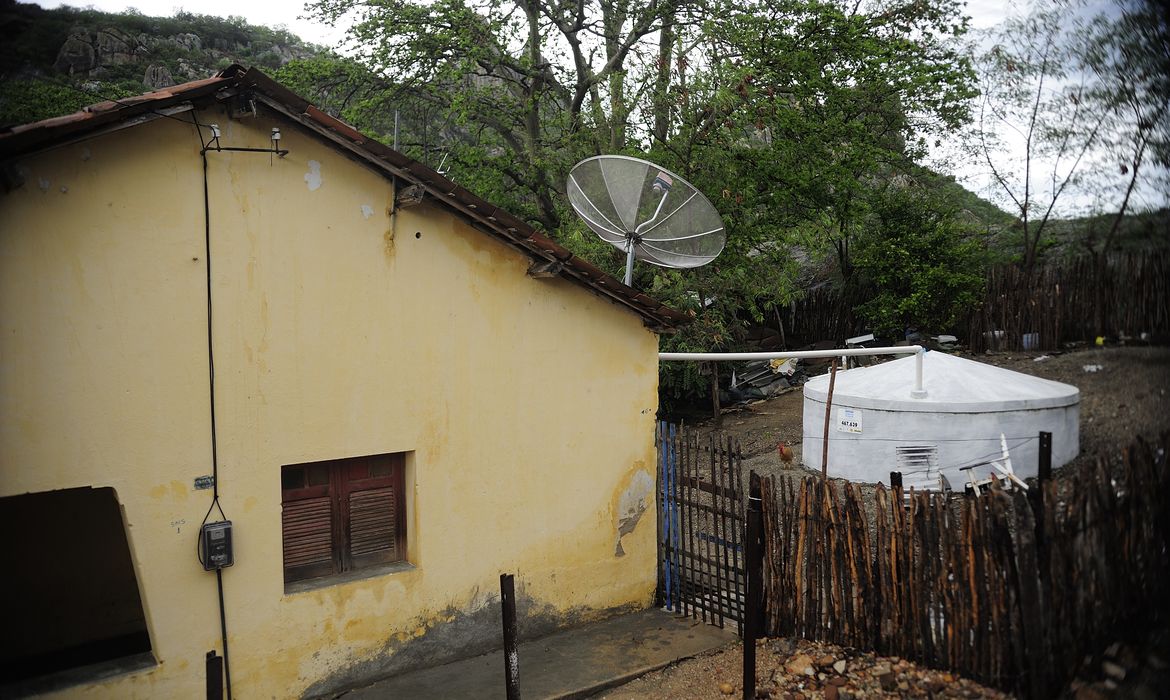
[569,156,727,286]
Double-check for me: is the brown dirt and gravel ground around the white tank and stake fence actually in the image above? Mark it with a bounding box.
[600,348,1170,700]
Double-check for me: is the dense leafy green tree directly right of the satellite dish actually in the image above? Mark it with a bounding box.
[654,0,973,385]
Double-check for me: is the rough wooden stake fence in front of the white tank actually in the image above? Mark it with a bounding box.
[762,434,1170,698]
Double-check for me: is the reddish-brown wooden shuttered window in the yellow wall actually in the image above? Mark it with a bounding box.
[281,452,407,585]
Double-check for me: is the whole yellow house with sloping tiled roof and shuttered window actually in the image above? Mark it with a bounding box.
[0,67,686,699]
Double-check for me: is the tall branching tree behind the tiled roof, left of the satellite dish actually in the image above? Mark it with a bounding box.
[310,0,675,231]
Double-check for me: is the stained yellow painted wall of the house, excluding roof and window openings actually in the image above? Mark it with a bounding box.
[0,105,658,698]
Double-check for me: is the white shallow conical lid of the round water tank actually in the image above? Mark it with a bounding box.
[804,352,1080,413]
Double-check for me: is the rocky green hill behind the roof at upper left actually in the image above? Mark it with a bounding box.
[0,0,324,125]
